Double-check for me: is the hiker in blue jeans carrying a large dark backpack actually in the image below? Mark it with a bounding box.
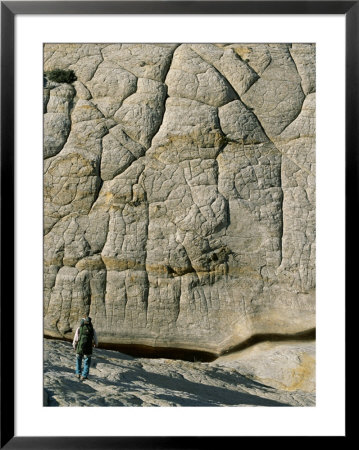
[72,316,98,381]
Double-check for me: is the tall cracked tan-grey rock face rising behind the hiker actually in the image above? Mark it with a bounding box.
[44,44,315,354]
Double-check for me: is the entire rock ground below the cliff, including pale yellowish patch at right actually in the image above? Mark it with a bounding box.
[44,339,315,407]
